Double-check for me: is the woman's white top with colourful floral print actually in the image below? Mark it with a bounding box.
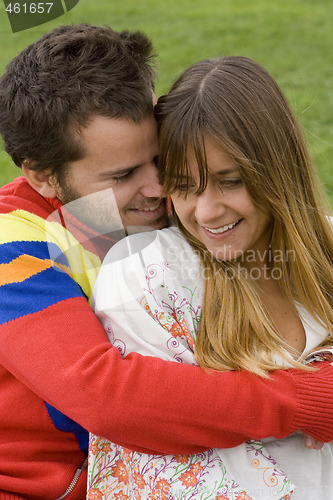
[87,228,333,500]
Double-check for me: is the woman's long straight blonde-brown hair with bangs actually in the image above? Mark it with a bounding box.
[156,57,333,376]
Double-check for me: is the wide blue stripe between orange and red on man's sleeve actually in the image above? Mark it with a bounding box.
[0,267,86,324]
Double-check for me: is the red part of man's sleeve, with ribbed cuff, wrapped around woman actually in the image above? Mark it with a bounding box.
[0,297,333,454]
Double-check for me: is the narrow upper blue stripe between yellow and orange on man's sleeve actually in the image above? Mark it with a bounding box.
[0,241,69,266]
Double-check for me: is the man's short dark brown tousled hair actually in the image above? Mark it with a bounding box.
[0,24,154,176]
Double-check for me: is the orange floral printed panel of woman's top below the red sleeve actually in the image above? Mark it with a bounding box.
[87,437,252,500]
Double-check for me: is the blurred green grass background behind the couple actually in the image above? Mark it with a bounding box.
[0,0,333,206]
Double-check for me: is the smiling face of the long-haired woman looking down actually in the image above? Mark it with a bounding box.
[171,136,271,263]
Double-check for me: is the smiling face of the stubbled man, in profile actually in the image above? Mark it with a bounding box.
[57,116,167,232]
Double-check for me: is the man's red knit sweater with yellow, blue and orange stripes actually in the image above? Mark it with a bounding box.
[0,177,333,500]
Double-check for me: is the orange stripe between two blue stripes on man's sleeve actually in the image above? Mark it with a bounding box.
[0,255,67,286]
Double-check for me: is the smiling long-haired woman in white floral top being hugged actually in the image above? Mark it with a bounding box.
[90,57,333,500]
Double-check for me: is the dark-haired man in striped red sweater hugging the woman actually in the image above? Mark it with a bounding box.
[0,25,333,500]
